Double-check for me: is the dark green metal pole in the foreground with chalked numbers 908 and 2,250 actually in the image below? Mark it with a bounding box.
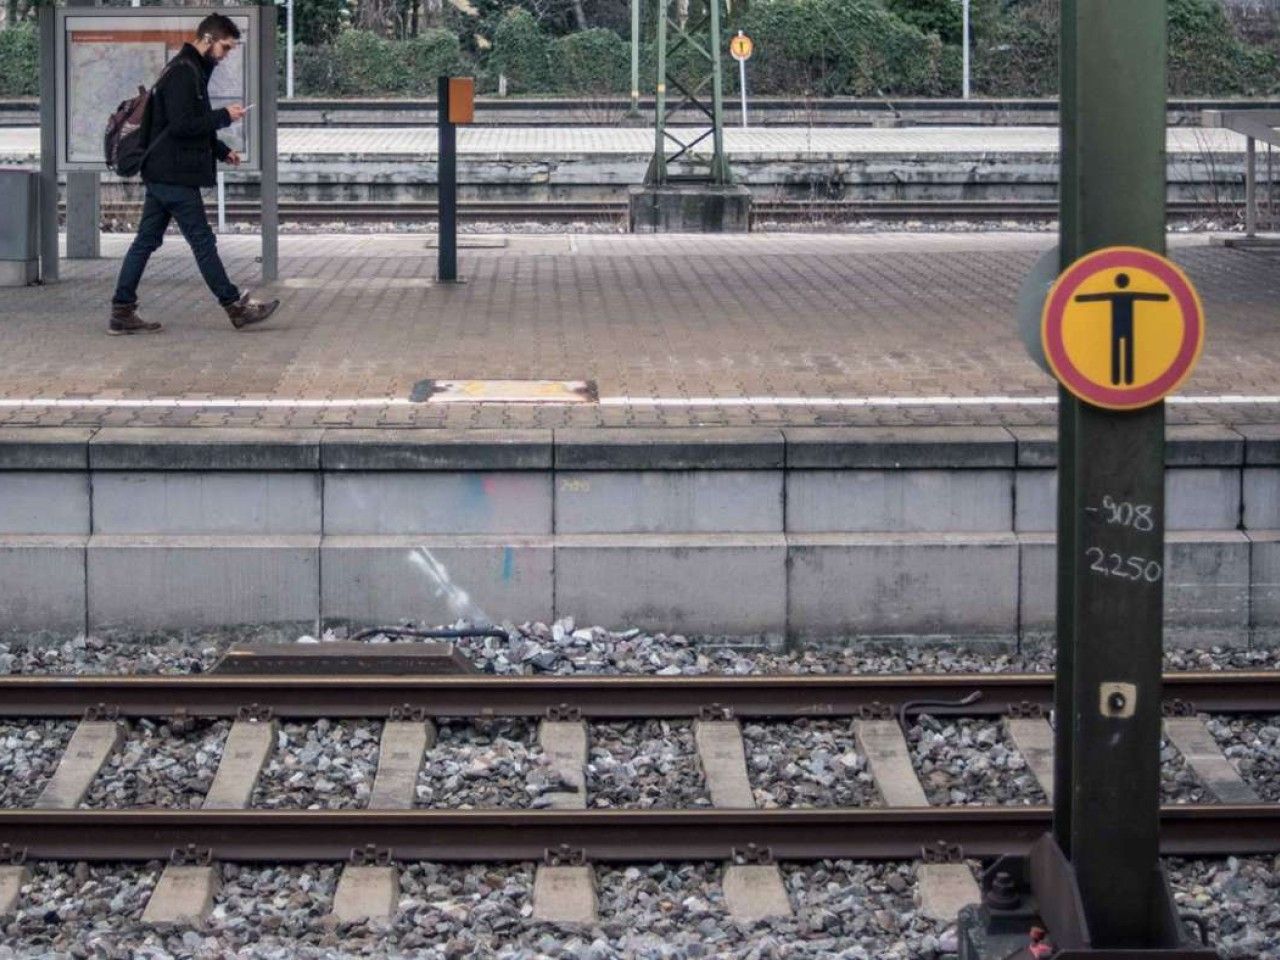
[1055,0,1167,948]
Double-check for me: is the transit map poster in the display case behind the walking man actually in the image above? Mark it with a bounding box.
[58,8,259,172]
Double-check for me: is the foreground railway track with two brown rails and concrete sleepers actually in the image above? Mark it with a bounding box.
[0,655,1280,957]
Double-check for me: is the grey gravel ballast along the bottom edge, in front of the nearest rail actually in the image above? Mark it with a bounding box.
[0,858,1280,960]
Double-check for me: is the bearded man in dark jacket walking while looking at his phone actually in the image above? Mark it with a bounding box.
[108,13,280,334]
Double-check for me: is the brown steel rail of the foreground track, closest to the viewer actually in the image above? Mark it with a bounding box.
[0,804,1280,861]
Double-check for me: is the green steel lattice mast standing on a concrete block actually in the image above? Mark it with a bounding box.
[644,0,733,184]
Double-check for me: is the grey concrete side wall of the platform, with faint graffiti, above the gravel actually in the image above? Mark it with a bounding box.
[0,426,1280,645]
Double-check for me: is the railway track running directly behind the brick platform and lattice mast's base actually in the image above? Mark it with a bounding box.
[90,200,1234,224]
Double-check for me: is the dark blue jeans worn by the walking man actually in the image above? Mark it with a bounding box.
[111,183,239,307]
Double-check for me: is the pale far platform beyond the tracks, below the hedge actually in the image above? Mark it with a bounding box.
[0,127,1245,204]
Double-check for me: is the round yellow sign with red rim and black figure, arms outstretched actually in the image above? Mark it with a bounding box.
[1041,247,1204,410]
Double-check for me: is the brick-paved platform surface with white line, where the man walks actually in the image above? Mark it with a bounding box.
[0,233,1280,428]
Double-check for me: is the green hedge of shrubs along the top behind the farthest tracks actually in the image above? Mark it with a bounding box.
[0,0,1280,97]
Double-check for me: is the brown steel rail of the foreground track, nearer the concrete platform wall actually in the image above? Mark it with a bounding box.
[0,671,1280,719]
